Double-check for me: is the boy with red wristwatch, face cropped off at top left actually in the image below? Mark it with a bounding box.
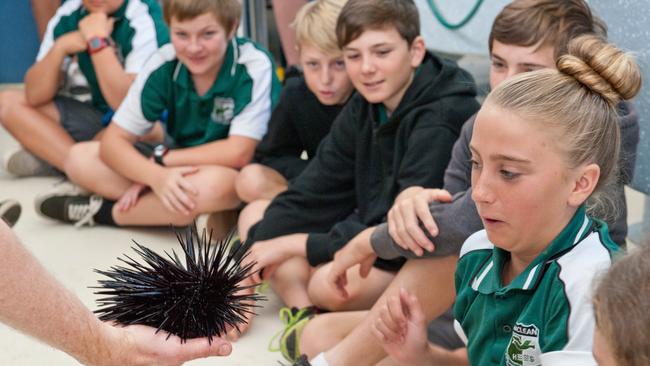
[0,0,169,177]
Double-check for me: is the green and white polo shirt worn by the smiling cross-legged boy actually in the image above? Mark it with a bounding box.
[113,38,280,147]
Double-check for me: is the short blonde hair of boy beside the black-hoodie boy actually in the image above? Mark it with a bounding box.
[291,0,348,54]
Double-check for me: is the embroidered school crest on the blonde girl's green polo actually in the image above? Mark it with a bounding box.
[506,323,541,366]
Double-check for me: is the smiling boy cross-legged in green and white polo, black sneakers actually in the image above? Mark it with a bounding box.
[36,0,280,226]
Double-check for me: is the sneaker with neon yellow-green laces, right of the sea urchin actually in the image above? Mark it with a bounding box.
[269,306,318,365]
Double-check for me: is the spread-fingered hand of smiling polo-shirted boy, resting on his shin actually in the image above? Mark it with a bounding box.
[150,166,199,216]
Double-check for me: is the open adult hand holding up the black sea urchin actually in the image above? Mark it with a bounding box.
[98,323,232,366]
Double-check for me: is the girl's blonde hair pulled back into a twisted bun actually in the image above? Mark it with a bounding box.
[485,35,641,218]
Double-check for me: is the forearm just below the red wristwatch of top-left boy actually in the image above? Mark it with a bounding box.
[90,47,134,110]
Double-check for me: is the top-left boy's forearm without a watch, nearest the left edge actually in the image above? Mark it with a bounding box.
[25,44,67,106]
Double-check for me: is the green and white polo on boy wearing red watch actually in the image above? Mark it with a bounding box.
[36,0,169,112]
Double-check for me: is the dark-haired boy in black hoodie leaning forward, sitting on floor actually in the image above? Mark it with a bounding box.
[237,0,478,346]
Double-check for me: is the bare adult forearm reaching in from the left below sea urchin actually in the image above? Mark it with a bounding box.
[0,220,107,362]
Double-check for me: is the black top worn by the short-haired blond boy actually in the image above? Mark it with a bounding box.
[255,76,343,180]
